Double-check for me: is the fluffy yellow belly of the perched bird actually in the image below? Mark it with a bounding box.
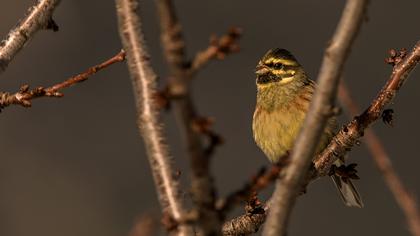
[253,107,305,162]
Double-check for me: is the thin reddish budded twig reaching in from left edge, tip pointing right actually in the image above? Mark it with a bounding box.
[0,51,125,110]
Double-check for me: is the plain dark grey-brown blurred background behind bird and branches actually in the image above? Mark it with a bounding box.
[0,0,420,236]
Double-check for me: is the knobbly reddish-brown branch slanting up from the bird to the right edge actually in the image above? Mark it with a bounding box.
[315,41,420,176]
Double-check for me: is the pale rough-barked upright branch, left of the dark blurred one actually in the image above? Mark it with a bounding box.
[116,0,193,235]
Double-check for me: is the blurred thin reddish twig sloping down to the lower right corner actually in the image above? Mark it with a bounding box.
[338,81,420,236]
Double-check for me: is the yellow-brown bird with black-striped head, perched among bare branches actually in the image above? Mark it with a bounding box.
[252,48,363,207]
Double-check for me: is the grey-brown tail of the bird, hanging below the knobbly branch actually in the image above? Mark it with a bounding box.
[331,163,363,208]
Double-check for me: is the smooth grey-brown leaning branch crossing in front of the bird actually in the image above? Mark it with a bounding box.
[263,0,368,236]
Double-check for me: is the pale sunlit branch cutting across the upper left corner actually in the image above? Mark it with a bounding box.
[0,0,60,74]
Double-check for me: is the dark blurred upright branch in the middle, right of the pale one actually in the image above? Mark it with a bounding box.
[156,0,222,235]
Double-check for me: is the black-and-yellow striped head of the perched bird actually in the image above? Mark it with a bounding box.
[255,48,306,88]
